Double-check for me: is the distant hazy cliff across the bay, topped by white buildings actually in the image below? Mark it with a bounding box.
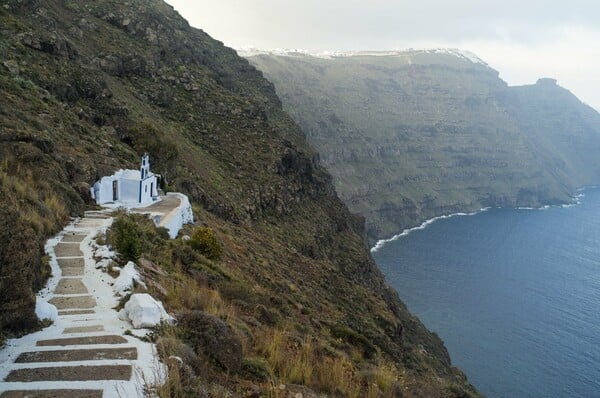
[248,51,600,241]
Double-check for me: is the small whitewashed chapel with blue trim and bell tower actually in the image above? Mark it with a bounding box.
[91,154,159,207]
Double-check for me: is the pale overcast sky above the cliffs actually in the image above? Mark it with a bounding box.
[166,0,600,110]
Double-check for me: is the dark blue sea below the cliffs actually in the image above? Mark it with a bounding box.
[373,189,600,398]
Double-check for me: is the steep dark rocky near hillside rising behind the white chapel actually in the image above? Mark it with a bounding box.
[0,0,476,396]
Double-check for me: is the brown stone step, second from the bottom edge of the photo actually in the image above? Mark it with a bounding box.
[5,365,132,382]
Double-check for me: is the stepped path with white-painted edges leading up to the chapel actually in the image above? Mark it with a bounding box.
[0,212,163,398]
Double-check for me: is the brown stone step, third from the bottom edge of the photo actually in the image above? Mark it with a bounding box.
[15,347,137,363]
